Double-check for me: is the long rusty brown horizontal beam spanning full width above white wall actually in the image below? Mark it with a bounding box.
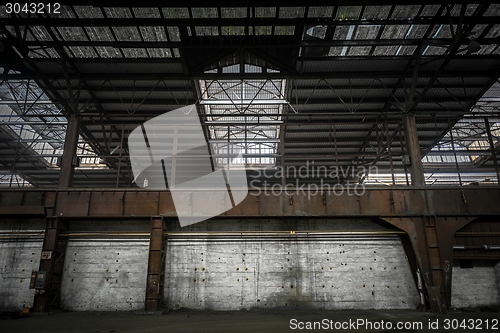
[0,185,500,218]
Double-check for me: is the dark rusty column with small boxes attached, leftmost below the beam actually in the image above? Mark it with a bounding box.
[33,210,68,312]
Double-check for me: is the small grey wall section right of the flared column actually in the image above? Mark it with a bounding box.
[451,261,500,308]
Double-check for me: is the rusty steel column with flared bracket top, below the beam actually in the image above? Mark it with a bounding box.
[383,216,474,312]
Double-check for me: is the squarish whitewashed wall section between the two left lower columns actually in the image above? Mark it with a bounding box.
[61,237,149,311]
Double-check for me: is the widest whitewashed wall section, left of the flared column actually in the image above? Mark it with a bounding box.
[165,221,419,310]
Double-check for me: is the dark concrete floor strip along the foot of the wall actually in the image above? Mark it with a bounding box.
[0,309,500,333]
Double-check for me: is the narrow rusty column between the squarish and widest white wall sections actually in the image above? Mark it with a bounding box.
[145,216,167,311]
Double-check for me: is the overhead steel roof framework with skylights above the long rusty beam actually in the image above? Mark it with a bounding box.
[0,1,500,187]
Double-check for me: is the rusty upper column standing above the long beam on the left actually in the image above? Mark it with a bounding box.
[58,114,80,187]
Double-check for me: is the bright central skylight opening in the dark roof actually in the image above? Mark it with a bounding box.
[199,64,288,169]
